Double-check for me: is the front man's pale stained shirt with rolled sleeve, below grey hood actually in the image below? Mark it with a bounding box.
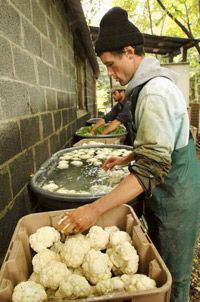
[129,80,189,191]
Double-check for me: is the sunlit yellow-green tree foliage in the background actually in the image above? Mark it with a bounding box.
[81,0,200,108]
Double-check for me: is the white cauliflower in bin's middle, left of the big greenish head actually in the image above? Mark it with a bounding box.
[82,249,112,284]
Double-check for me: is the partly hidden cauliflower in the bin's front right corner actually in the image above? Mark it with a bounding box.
[121,274,156,292]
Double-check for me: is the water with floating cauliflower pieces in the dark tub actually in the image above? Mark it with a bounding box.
[40,147,130,195]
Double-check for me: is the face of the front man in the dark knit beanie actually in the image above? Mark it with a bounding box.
[100,51,134,85]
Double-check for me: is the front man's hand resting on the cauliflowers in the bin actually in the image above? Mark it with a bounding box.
[56,203,99,235]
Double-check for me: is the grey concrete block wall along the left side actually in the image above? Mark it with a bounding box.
[0,0,92,262]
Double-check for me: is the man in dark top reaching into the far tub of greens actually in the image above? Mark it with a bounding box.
[90,85,133,146]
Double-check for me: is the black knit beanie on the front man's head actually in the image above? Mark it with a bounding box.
[95,6,144,54]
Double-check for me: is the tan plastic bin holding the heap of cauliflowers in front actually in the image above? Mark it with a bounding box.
[0,205,172,302]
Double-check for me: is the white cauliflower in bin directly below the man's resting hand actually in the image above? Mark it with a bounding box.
[61,234,90,268]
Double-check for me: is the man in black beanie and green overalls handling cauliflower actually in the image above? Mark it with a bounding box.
[58,7,200,302]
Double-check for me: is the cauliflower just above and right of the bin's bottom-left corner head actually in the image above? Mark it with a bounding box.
[40,260,71,289]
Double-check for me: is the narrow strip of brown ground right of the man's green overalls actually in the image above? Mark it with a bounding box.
[190,236,200,302]
